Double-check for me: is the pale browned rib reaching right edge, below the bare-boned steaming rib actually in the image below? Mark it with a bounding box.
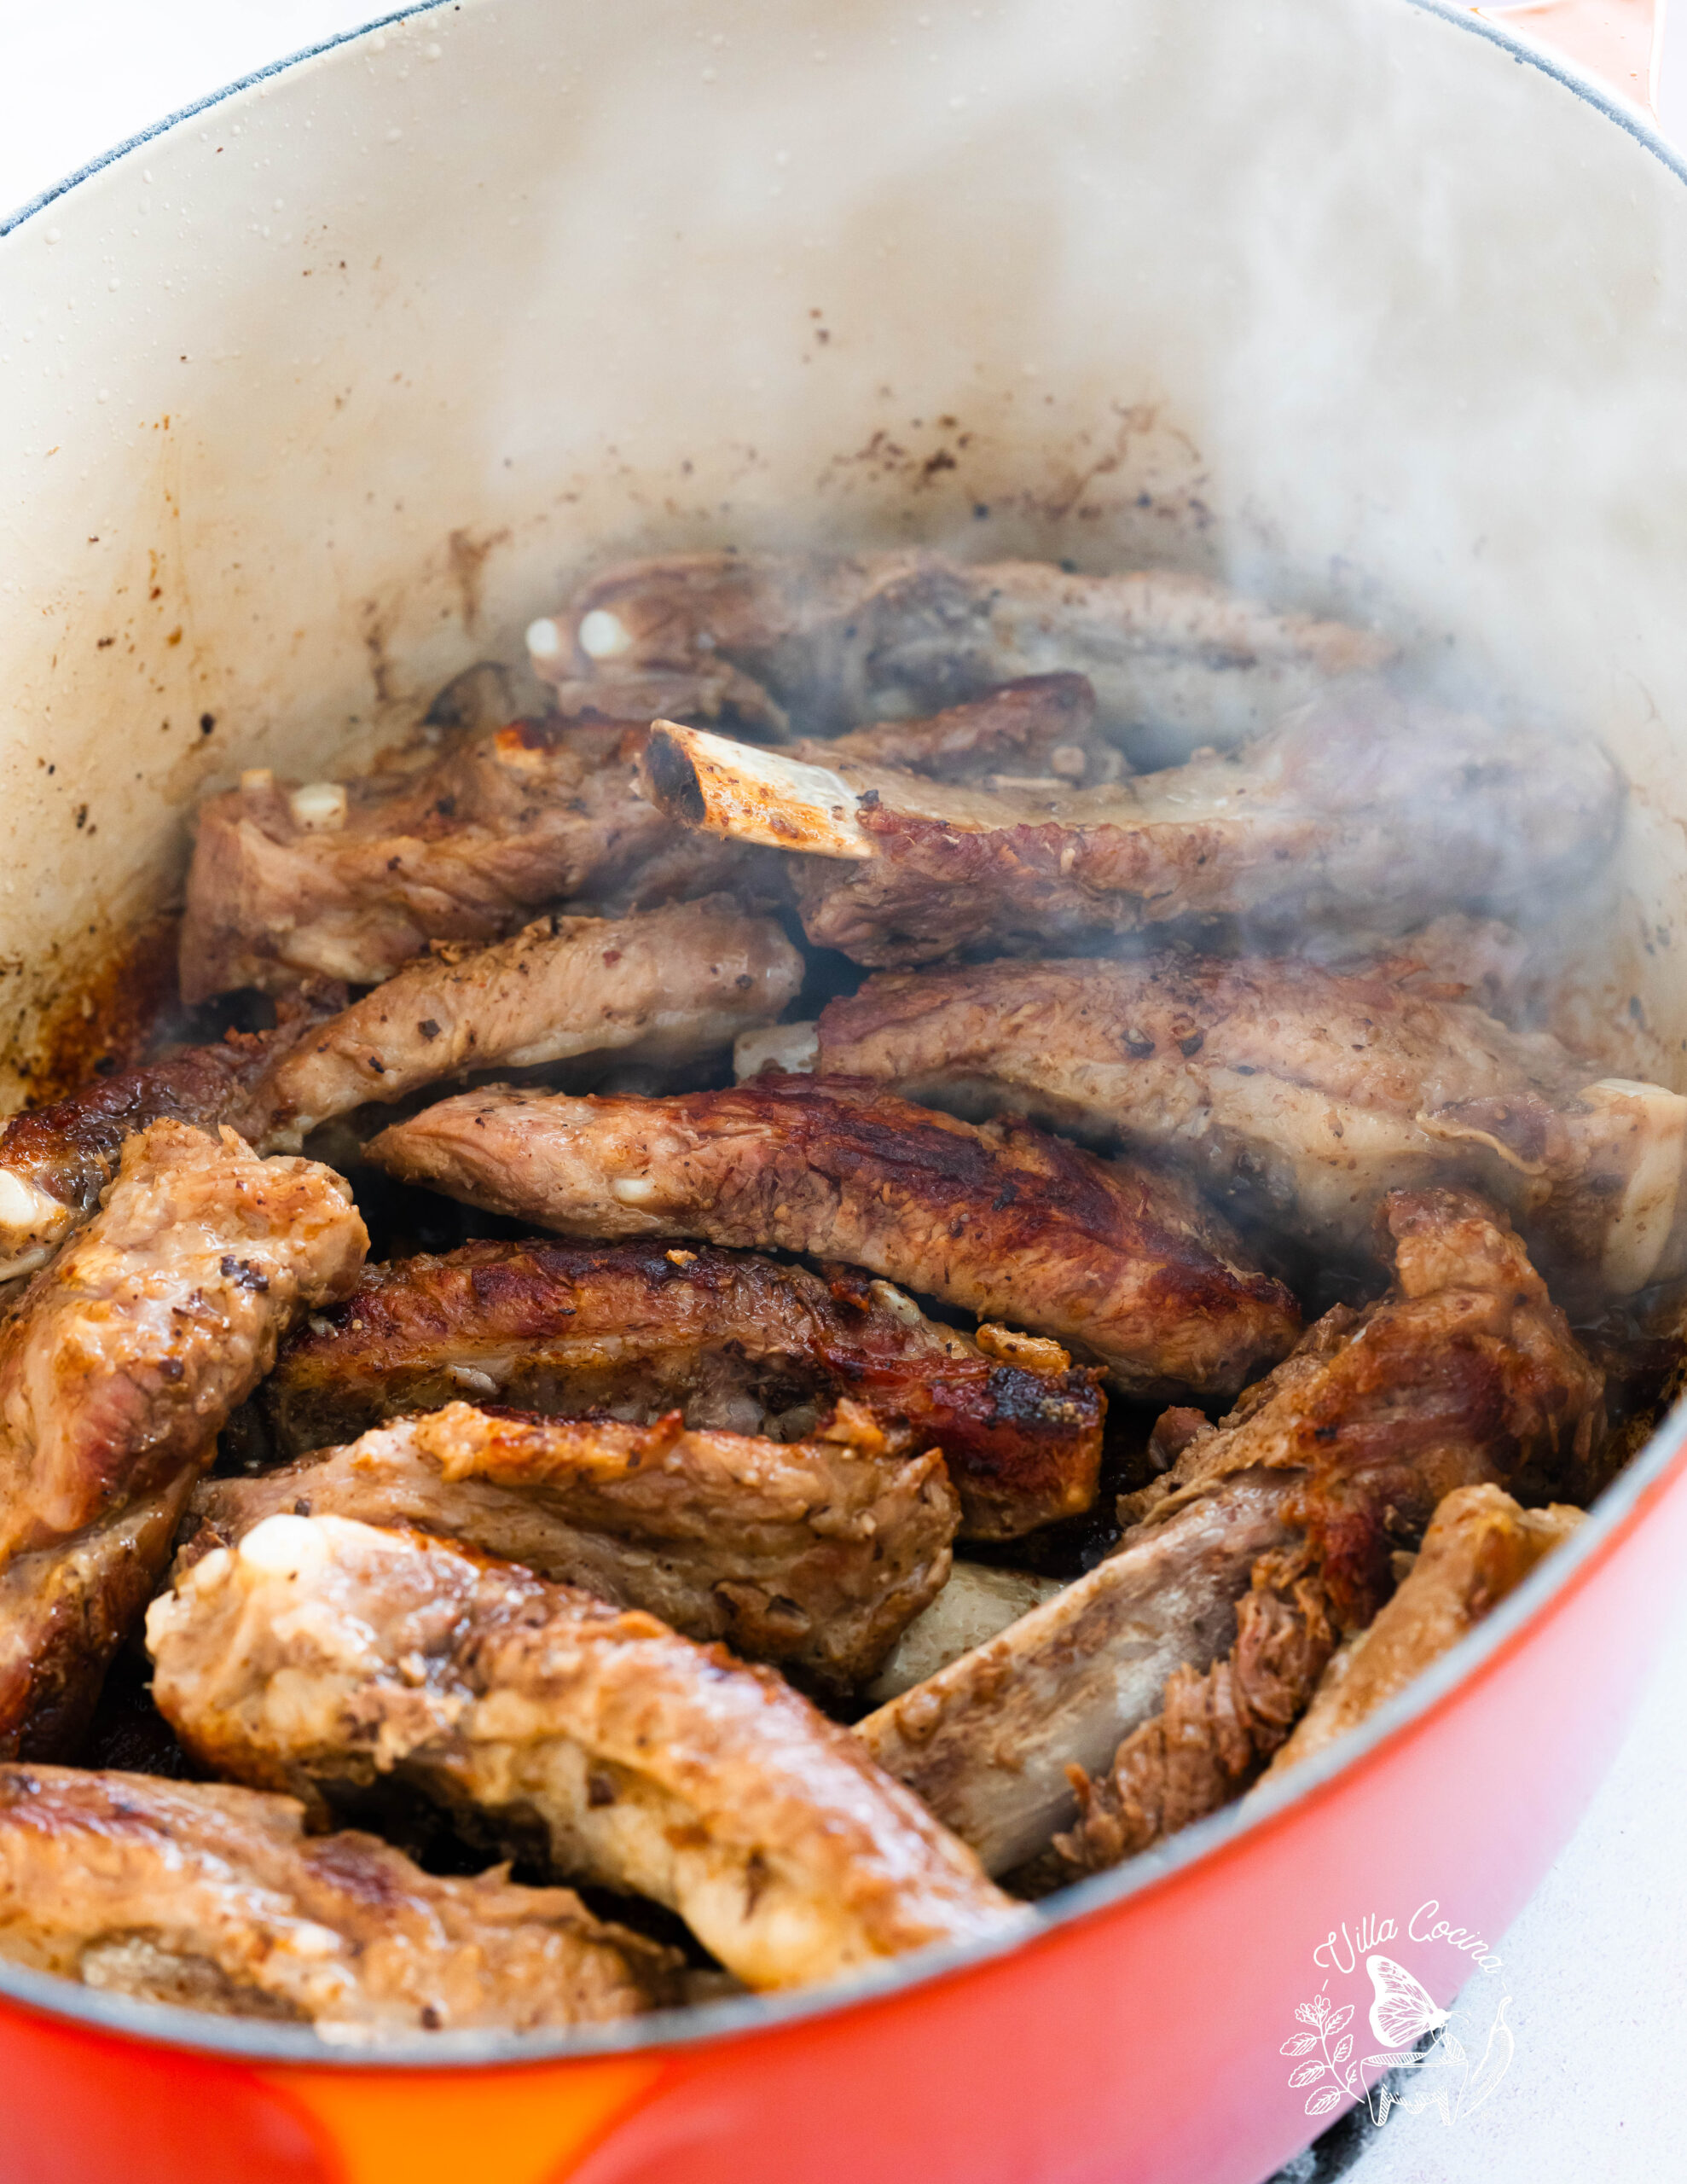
[816,952,1687,1293]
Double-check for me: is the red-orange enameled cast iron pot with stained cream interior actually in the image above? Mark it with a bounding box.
[0,0,1687,2184]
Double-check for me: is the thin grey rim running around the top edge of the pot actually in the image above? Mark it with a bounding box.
[0,0,1687,2072]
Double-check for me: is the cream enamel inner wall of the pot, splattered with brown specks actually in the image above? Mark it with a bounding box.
[0,0,1687,2166]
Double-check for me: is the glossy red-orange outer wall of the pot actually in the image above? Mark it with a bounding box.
[0,1414,1687,2184]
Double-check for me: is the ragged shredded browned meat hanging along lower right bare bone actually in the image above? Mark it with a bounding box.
[1054,1544,1336,1880]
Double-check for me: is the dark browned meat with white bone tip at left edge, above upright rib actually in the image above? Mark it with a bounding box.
[0,996,343,1280]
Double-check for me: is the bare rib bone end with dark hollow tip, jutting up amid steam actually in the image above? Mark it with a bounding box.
[640,721,873,858]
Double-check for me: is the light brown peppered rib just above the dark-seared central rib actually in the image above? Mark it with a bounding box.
[260,896,803,1144]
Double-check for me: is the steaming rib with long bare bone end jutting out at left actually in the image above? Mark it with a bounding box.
[644,686,1621,966]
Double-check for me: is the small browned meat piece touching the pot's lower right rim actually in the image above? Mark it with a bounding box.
[1266,1485,1582,1780]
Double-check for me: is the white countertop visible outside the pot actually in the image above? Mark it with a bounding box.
[0,0,1687,2184]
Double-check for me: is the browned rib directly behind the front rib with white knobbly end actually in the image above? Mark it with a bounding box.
[194,1400,960,1688]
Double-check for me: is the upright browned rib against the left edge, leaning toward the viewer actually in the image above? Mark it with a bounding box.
[0,1120,368,1758]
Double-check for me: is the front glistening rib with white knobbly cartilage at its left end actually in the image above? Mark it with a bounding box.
[146,1516,1015,1988]
